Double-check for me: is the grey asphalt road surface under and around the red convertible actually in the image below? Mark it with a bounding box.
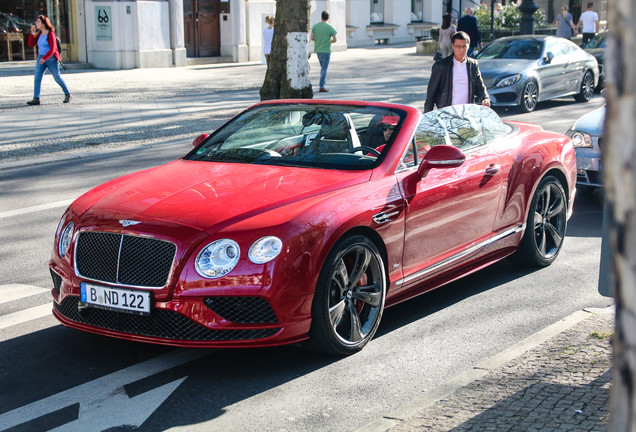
[0,91,611,431]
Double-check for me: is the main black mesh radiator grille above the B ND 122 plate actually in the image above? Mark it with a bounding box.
[75,231,177,288]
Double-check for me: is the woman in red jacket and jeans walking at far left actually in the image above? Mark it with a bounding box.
[27,15,71,105]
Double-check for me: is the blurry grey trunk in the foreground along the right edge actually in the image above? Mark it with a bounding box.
[603,0,636,432]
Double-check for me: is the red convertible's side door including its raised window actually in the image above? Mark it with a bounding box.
[397,105,503,285]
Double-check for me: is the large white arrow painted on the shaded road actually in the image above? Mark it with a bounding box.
[0,349,209,432]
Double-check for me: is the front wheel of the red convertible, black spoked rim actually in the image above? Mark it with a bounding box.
[309,235,387,355]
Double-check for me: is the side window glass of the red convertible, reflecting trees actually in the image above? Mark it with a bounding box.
[403,104,511,166]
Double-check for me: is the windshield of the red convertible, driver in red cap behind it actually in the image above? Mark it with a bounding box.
[185,104,406,170]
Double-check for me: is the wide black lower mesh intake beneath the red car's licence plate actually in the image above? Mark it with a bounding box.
[54,296,280,341]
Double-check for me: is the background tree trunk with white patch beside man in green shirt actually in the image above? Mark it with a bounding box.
[260,0,314,100]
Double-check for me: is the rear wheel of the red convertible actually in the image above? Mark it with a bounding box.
[517,176,568,267]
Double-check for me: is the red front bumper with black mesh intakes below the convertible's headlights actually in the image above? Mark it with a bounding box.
[51,270,313,348]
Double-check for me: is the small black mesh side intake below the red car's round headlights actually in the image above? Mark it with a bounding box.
[203,297,278,324]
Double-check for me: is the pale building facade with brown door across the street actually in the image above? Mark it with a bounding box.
[0,0,478,69]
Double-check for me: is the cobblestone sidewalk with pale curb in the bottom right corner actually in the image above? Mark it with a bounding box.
[358,307,614,432]
